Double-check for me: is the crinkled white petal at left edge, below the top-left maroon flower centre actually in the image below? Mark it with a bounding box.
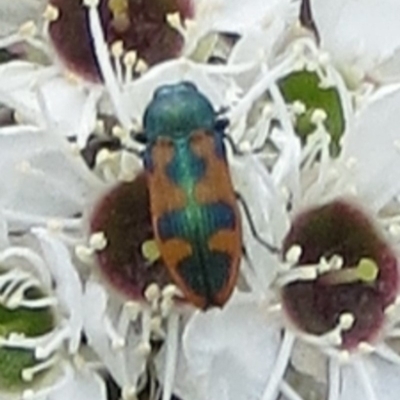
[0,61,102,142]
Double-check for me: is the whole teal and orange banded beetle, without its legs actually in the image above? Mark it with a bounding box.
[143,82,242,309]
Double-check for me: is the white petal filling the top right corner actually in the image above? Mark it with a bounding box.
[311,0,400,75]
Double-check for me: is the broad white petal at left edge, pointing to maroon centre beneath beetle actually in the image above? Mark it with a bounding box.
[0,126,100,229]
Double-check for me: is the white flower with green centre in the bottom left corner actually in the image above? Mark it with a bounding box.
[0,216,106,400]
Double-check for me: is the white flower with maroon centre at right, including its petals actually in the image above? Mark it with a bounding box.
[181,79,400,400]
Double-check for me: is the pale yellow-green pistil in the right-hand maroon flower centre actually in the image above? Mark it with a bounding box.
[318,258,379,285]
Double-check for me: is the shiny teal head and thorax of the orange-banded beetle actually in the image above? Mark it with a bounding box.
[143,82,216,141]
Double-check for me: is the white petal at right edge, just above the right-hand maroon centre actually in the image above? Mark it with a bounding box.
[342,86,400,209]
